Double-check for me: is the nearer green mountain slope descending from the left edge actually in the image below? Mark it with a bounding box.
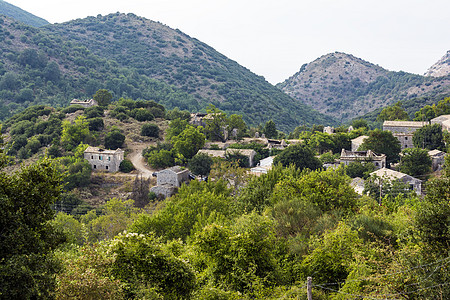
[0,16,202,120]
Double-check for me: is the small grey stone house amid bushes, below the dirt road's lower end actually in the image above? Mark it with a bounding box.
[150,166,190,198]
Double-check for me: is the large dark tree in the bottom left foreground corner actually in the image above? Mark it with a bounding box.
[0,159,64,299]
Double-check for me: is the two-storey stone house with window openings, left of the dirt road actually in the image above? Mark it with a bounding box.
[84,147,124,172]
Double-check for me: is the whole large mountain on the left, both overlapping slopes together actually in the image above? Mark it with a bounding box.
[0,13,335,131]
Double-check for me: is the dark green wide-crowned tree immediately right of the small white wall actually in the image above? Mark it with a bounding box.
[273,144,322,170]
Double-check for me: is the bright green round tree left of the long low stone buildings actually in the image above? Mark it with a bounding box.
[172,125,205,160]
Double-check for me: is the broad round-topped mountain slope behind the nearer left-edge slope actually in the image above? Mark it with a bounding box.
[44,13,334,131]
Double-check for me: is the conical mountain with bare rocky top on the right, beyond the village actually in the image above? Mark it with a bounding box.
[277,52,450,122]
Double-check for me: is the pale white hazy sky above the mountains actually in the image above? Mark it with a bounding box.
[7,0,450,84]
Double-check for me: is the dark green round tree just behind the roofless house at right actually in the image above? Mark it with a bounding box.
[399,148,431,177]
